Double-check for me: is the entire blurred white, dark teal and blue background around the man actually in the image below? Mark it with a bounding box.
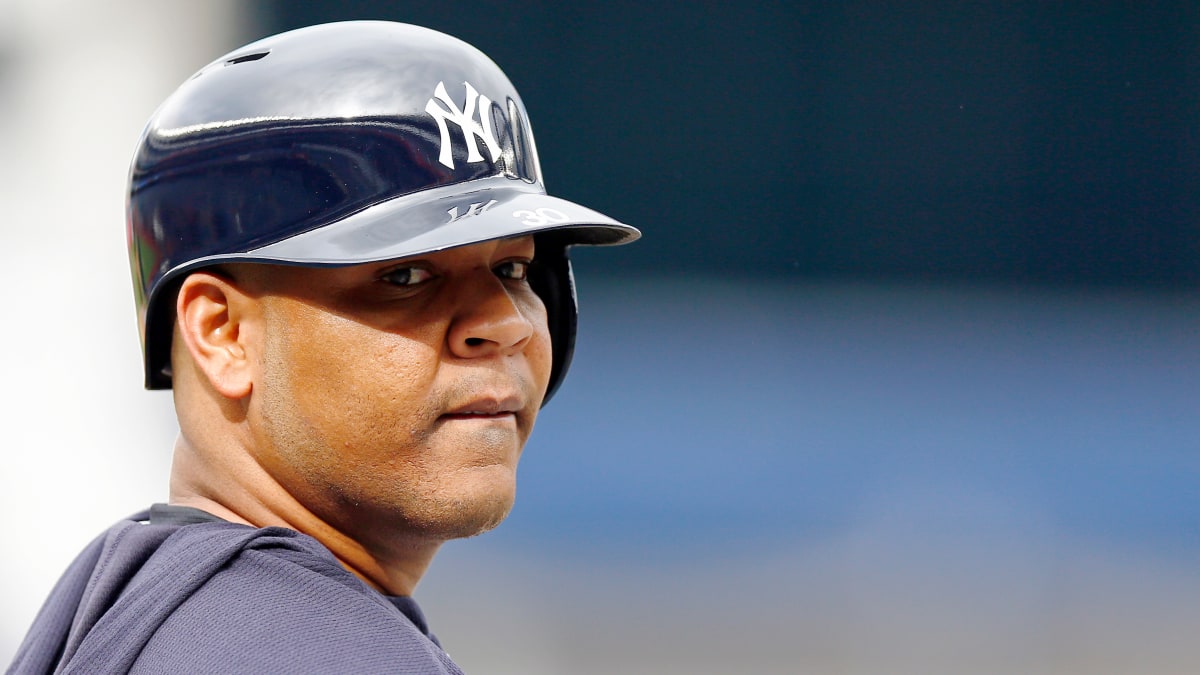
[0,0,1200,674]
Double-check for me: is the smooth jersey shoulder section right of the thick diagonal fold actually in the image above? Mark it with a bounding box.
[125,524,457,673]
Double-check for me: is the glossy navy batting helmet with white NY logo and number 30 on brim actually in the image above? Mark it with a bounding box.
[127,22,640,400]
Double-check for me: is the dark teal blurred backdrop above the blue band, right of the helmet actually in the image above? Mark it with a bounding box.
[254,1,1200,283]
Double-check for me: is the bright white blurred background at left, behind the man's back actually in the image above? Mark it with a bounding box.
[0,0,244,662]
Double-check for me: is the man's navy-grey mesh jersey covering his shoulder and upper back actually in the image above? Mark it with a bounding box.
[14,514,458,673]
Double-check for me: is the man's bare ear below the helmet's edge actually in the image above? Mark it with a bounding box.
[175,271,257,399]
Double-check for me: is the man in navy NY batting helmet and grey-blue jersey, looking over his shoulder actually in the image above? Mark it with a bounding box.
[11,22,638,673]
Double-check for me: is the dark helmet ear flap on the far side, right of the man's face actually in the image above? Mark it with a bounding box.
[529,234,578,406]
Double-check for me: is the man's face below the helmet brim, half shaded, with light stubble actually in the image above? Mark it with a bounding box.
[233,237,551,545]
